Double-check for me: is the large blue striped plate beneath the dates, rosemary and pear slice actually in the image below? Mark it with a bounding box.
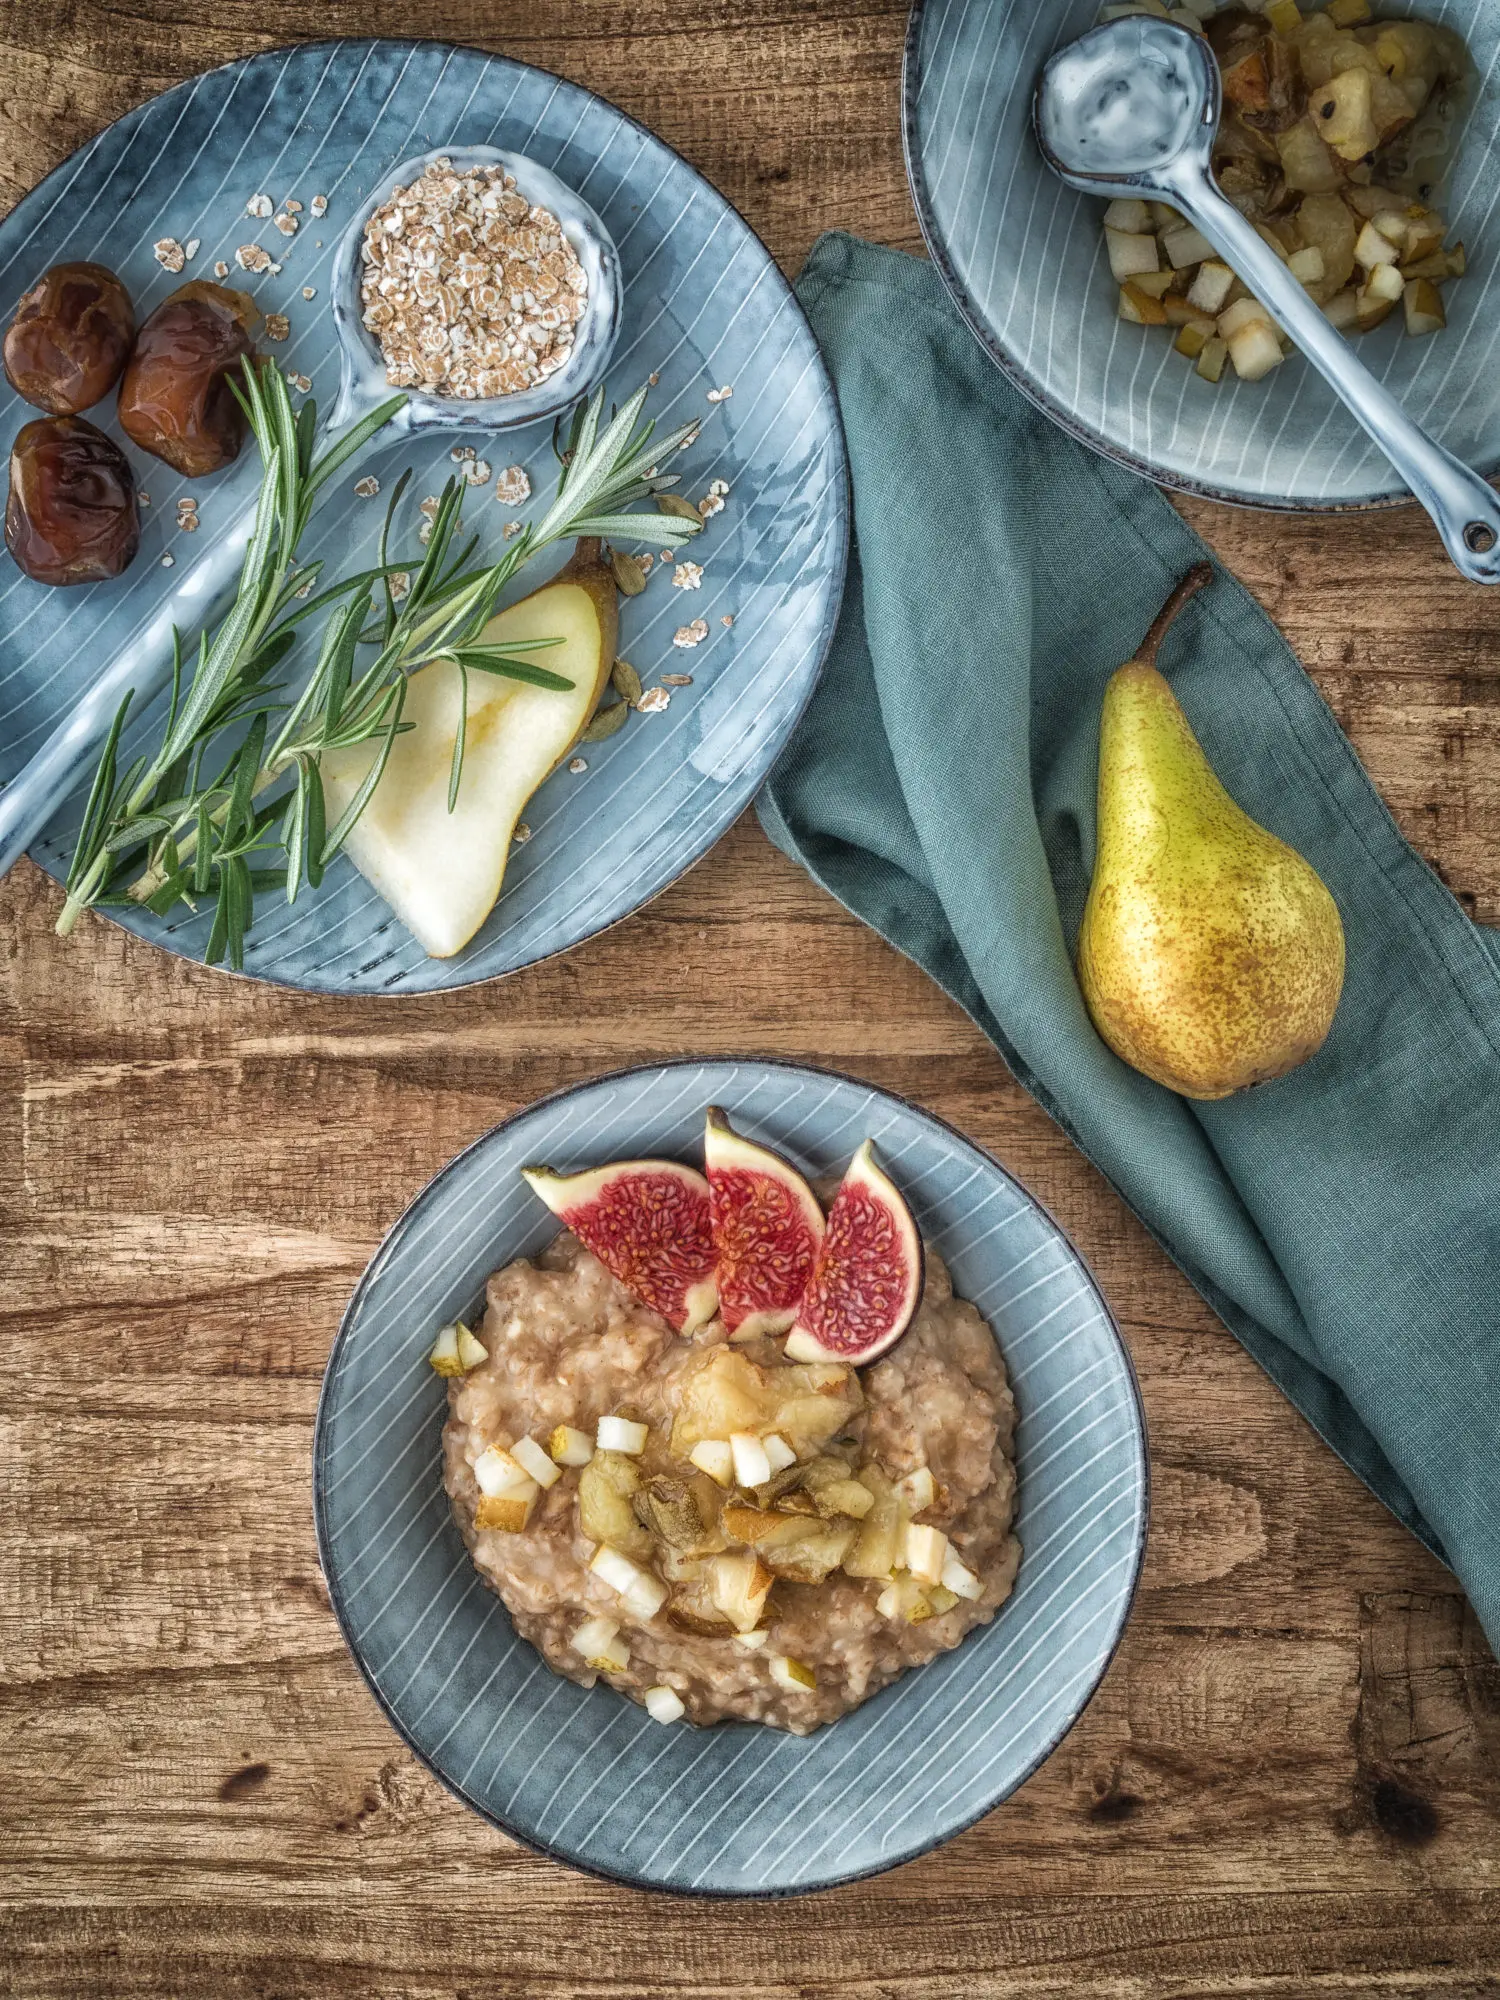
[0,40,848,994]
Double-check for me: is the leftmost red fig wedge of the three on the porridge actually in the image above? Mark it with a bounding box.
[522,1160,718,1334]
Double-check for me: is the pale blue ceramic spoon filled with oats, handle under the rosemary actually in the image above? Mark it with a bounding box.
[0,146,620,876]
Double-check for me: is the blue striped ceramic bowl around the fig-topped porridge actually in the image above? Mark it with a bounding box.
[314,1060,1146,1896]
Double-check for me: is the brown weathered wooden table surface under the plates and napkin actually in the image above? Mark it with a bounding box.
[0,0,1500,2000]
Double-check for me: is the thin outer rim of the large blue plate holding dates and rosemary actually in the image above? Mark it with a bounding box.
[0,34,854,1002]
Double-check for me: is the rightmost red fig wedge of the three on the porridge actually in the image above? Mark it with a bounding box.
[786,1140,922,1366]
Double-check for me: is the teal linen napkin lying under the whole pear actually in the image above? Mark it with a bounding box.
[760,236,1500,1644]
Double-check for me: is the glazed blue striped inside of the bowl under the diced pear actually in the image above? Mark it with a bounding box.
[904,0,1500,508]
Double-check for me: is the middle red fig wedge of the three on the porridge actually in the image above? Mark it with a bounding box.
[704,1104,824,1340]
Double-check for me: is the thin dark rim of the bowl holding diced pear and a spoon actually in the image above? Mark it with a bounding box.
[902,0,1448,514]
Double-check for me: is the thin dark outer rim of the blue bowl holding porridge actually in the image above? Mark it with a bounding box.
[310,1050,1152,1902]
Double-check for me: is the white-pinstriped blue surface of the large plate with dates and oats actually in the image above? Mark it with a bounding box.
[0,44,844,992]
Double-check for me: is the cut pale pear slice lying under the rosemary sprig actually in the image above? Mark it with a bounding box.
[322,540,620,958]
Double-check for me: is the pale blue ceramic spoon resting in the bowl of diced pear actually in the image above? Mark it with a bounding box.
[1034,14,1500,584]
